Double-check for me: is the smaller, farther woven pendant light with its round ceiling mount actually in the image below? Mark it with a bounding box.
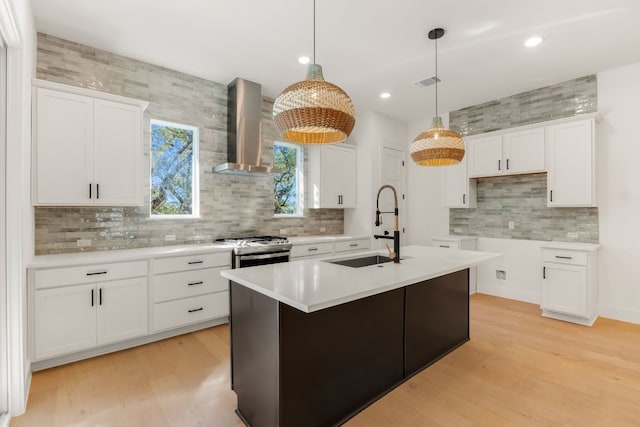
[410,28,464,166]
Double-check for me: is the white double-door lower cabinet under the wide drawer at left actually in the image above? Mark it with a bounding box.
[34,277,148,360]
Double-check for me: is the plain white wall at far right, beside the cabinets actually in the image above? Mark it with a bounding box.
[597,63,640,323]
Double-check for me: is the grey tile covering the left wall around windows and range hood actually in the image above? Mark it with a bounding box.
[35,34,344,255]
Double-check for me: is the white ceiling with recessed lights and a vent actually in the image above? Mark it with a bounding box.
[32,0,640,120]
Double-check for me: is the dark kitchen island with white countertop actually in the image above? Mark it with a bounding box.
[221,246,499,427]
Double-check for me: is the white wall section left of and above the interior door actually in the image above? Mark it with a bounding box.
[344,110,408,247]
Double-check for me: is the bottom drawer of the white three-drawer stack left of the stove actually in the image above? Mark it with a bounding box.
[153,291,229,331]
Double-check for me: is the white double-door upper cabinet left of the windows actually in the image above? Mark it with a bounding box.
[32,81,147,206]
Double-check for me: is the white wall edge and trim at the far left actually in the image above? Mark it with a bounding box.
[0,0,36,416]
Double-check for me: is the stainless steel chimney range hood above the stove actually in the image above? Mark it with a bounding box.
[213,78,282,175]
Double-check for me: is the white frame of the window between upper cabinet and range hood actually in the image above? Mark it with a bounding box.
[149,119,200,220]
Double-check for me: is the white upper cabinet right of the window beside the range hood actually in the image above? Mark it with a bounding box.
[308,145,356,209]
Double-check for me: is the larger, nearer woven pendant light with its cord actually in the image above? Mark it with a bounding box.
[273,0,356,144]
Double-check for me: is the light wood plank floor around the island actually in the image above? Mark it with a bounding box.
[11,295,640,427]
